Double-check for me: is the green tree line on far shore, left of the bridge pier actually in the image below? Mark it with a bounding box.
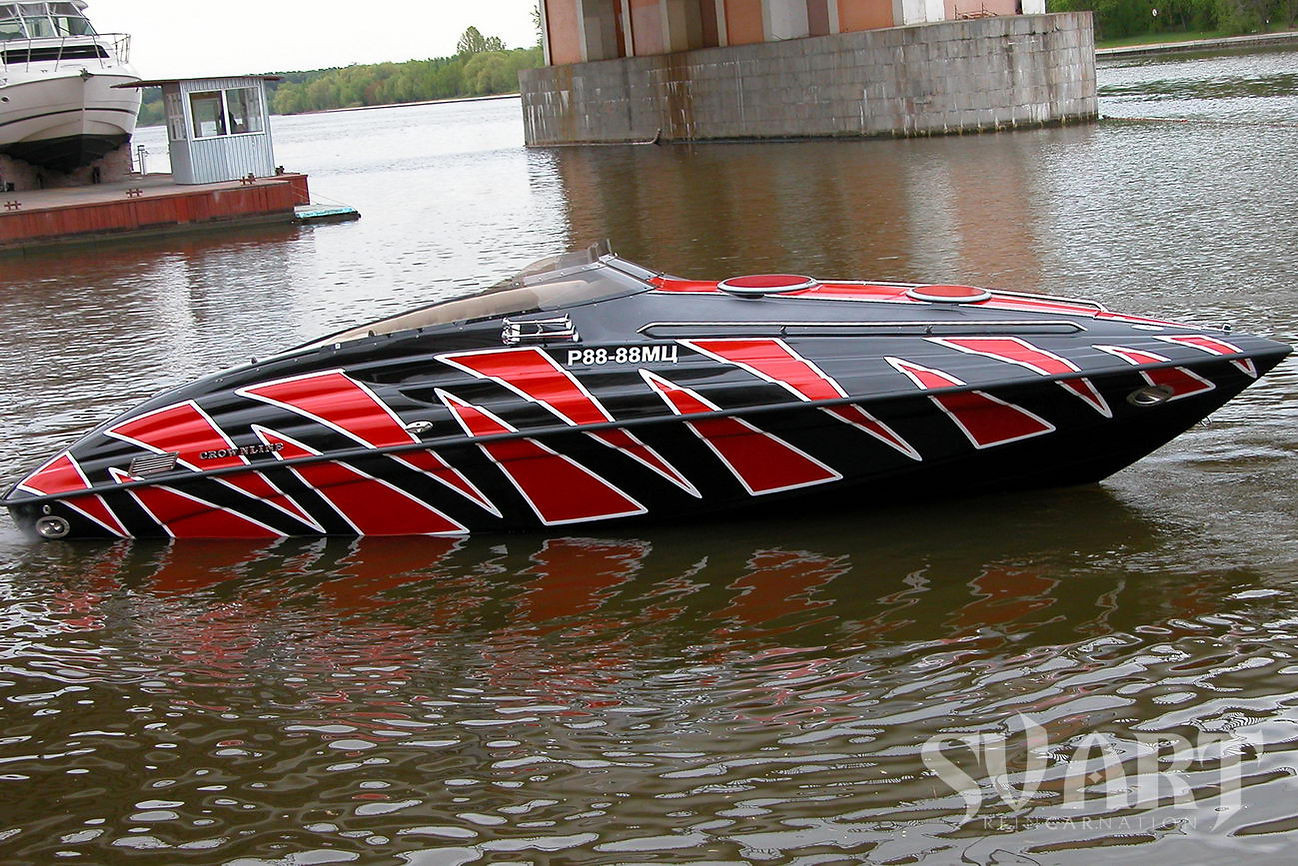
[138,27,543,126]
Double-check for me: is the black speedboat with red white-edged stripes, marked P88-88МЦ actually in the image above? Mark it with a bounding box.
[3,247,1290,539]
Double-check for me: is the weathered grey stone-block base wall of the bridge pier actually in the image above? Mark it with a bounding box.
[519,12,1098,145]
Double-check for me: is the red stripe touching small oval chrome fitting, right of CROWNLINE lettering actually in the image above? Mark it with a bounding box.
[235,370,500,517]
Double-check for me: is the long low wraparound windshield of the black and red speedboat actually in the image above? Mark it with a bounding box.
[297,244,655,349]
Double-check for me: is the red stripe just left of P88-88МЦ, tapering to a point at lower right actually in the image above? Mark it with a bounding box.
[437,348,698,496]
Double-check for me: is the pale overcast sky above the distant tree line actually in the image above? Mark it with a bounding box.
[86,0,536,79]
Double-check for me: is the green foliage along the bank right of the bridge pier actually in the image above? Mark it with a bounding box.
[1047,0,1298,39]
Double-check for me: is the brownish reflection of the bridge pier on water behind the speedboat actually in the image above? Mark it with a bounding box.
[552,130,1044,291]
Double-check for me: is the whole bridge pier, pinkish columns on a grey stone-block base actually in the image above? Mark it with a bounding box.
[522,0,1097,144]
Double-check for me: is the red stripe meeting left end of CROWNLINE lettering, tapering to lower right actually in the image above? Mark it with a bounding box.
[108,400,321,530]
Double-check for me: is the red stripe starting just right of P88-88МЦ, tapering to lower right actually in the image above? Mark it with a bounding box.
[680,338,923,460]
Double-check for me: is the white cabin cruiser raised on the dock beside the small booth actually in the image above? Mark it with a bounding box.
[0,0,140,171]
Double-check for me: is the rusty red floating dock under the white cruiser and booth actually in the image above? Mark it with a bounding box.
[0,174,342,254]
